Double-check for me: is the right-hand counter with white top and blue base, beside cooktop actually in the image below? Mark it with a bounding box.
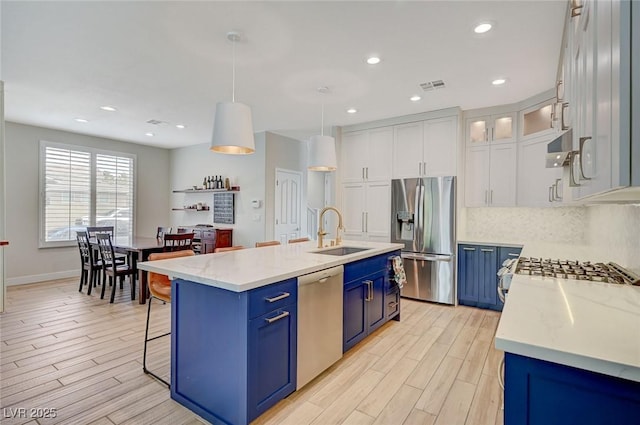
[495,244,640,425]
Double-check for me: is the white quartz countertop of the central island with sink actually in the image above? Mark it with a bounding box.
[138,241,402,292]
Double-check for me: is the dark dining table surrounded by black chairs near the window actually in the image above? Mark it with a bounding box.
[89,236,164,304]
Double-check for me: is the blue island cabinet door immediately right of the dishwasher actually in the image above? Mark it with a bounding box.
[342,279,368,352]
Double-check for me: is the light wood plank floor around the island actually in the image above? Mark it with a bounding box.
[0,279,503,425]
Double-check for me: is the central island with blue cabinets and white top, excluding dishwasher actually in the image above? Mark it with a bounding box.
[139,241,401,424]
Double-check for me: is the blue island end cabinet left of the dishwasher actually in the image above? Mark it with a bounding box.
[171,278,298,425]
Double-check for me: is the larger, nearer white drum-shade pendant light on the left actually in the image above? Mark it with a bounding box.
[209,31,256,155]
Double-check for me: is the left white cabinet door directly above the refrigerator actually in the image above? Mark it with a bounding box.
[393,121,424,179]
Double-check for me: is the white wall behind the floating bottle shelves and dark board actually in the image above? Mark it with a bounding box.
[167,133,265,247]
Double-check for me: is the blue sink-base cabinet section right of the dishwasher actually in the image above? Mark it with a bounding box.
[342,251,400,352]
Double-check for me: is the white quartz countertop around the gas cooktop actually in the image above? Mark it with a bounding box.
[495,244,640,382]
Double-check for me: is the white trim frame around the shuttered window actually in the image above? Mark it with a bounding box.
[38,140,138,248]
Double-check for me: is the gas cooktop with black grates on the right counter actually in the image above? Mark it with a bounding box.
[516,257,640,285]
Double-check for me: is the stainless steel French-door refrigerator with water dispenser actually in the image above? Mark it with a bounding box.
[391,177,456,304]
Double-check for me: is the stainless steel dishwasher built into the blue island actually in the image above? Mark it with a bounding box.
[296,266,344,389]
